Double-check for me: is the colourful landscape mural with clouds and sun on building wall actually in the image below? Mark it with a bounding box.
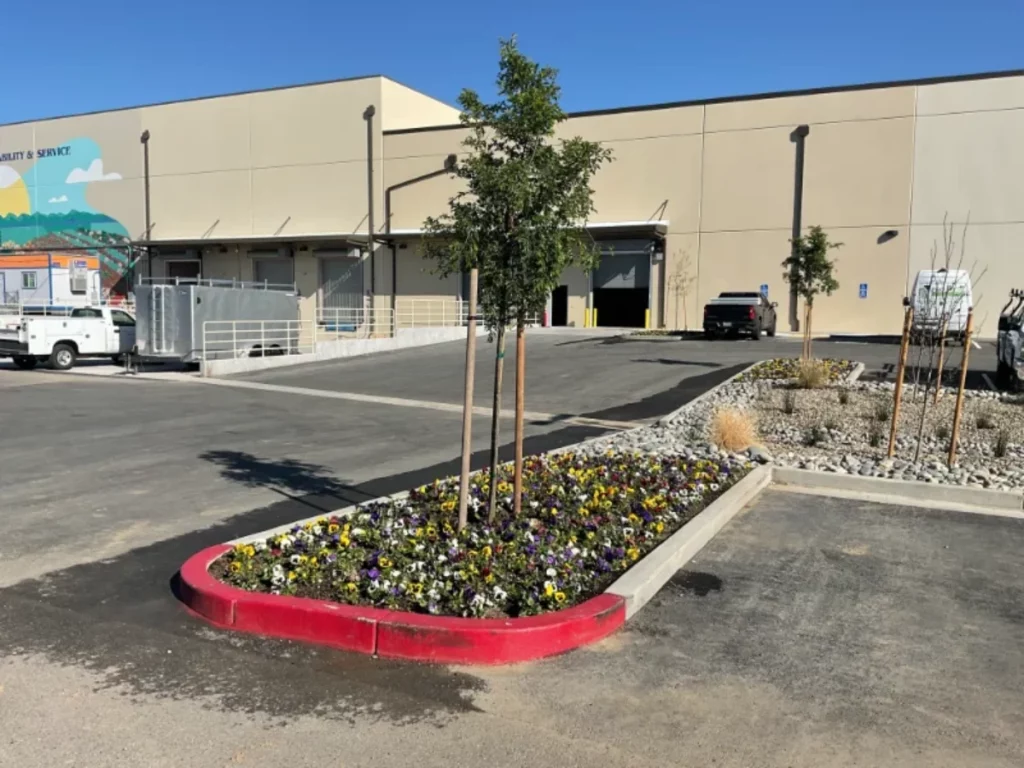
[0,138,132,292]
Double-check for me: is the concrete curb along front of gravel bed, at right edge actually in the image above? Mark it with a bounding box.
[772,467,1024,512]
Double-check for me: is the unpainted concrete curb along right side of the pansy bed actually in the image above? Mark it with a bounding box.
[605,466,771,620]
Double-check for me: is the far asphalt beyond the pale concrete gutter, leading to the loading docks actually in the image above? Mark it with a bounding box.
[237,330,995,420]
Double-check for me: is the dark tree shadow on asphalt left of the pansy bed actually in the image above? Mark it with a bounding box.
[199,451,370,512]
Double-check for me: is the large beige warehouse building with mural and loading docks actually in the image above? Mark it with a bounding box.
[0,72,1024,336]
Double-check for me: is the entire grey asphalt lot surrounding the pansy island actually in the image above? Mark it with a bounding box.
[0,334,1024,768]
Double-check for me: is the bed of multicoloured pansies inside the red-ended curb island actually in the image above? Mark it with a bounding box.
[210,454,751,617]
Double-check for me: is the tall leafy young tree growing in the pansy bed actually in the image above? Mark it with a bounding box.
[424,37,611,517]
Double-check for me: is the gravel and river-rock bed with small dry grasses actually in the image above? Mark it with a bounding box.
[585,364,1024,490]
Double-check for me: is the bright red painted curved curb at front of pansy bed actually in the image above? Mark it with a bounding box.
[180,544,626,665]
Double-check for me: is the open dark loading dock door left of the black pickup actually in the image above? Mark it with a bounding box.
[593,240,654,328]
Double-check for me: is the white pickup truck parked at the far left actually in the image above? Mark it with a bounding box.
[0,306,135,371]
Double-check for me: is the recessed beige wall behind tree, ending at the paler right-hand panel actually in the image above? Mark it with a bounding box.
[384,87,914,333]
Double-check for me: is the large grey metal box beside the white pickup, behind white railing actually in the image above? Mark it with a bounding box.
[135,278,299,362]
